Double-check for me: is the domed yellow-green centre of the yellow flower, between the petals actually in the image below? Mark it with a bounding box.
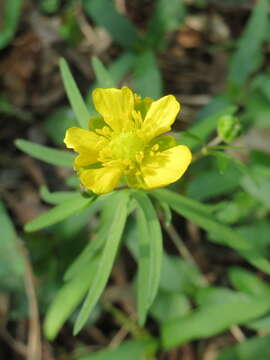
[110,132,144,160]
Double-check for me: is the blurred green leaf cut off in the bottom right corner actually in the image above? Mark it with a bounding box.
[216,335,270,360]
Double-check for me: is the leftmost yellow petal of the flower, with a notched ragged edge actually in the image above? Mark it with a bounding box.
[64,127,107,169]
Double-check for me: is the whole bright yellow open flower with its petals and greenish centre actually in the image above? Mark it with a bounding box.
[64,87,191,194]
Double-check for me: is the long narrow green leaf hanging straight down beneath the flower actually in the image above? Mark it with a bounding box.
[134,191,163,325]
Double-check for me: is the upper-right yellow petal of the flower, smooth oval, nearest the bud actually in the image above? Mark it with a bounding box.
[142,95,180,140]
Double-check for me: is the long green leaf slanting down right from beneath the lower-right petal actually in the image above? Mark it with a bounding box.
[151,189,250,249]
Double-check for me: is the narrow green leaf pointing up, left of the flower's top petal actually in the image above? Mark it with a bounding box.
[59,59,90,129]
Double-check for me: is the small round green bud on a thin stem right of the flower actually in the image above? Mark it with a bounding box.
[217,115,242,143]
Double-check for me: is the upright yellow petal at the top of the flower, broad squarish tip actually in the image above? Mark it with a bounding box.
[93,86,134,132]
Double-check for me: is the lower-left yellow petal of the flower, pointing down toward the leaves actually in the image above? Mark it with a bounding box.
[80,166,122,194]
